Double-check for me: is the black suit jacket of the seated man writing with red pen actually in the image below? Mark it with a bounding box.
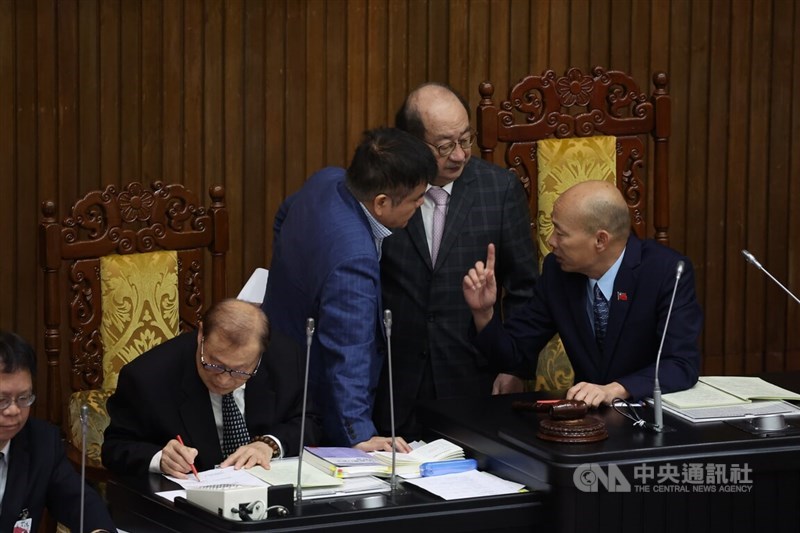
[102,331,319,474]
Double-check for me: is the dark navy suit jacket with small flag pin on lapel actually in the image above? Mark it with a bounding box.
[475,235,703,399]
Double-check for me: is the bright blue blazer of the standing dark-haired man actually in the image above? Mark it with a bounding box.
[262,167,392,446]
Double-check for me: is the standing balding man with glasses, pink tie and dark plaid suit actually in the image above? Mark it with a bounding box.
[375,83,537,438]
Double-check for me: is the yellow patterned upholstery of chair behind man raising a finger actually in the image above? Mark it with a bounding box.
[534,136,616,391]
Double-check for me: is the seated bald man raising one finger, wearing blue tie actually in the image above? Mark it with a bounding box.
[463,181,703,407]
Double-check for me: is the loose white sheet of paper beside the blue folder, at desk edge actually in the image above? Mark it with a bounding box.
[405,470,525,500]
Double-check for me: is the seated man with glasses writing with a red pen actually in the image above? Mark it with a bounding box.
[102,300,319,478]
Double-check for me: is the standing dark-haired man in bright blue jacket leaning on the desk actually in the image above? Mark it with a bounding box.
[262,128,436,451]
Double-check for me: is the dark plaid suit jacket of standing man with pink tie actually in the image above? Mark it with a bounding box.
[375,156,537,432]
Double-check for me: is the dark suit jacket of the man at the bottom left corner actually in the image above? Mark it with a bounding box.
[0,418,116,532]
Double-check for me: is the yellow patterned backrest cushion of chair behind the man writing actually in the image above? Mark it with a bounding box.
[100,251,180,389]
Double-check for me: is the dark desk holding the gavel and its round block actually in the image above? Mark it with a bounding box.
[421,375,800,533]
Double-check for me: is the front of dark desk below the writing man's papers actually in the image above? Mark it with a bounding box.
[107,474,543,533]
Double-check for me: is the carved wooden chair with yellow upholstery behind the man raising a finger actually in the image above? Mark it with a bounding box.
[477,67,670,390]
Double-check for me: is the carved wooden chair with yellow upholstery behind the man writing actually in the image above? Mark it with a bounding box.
[39,182,228,480]
